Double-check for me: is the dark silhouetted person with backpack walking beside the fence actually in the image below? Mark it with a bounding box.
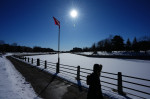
[87,64,103,99]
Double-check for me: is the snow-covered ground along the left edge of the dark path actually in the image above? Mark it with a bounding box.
[0,57,37,99]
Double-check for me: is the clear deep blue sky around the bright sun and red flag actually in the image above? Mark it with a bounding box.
[0,0,150,51]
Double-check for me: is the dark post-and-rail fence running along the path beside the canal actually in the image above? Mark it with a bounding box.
[19,57,150,99]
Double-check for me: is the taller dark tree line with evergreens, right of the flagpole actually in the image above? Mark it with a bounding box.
[71,35,150,53]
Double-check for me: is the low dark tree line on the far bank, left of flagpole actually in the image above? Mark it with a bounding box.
[0,40,54,52]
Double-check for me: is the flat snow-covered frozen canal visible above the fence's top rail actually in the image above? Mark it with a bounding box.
[27,53,150,79]
